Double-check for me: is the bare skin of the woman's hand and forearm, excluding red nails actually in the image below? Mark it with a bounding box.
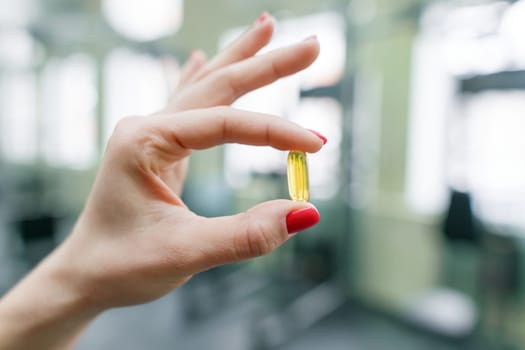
[0,14,322,350]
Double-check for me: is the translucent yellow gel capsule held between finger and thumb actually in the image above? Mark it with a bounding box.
[287,151,310,202]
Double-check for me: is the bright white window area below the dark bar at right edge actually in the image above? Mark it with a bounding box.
[463,91,525,227]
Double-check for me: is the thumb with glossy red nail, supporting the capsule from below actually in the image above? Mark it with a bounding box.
[189,200,320,268]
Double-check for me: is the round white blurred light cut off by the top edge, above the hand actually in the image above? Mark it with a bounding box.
[102,0,183,41]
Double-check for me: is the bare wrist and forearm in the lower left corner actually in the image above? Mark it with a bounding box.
[0,241,103,350]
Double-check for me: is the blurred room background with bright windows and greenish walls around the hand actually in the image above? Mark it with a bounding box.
[0,0,525,350]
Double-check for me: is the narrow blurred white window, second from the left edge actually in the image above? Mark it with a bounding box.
[42,54,97,169]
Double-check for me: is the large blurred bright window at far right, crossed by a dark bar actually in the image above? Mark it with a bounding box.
[407,0,525,214]
